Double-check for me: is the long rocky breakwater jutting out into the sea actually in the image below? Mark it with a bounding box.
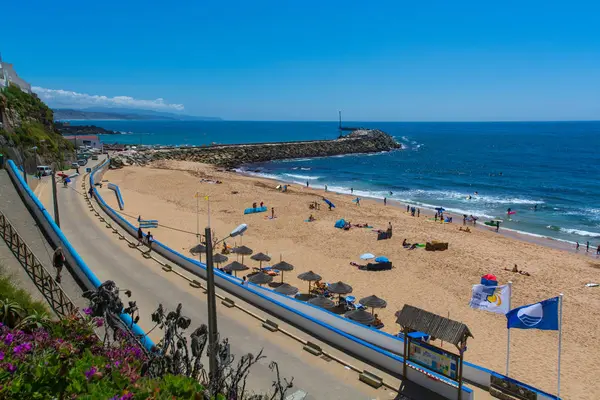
[111,129,402,168]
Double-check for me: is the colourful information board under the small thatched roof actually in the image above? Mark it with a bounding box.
[408,340,459,380]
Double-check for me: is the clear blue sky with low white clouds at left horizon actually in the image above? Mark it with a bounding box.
[0,0,600,121]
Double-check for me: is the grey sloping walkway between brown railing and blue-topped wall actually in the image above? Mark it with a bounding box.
[0,170,87,308]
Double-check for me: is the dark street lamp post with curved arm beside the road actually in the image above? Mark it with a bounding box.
[204,224,248,378]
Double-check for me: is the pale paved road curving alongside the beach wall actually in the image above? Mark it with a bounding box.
[52,158,404,400]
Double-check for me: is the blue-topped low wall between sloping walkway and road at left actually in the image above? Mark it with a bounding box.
[7,160,154,350]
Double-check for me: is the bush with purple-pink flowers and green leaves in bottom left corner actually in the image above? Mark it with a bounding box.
[0,317,204,400]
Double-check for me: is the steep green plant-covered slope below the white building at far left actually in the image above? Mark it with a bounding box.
[0,85,73,173]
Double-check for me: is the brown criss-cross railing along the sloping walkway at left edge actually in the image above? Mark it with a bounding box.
[0,211,78,319]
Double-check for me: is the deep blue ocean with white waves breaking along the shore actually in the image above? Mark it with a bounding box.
[73,121,600,246]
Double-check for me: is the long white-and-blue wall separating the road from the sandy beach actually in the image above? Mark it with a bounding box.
[90,161,558,399]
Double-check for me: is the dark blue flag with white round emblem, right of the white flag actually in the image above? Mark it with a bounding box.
[506,297,559,331]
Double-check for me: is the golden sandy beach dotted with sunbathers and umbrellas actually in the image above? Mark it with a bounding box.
[101,161,600,399]
